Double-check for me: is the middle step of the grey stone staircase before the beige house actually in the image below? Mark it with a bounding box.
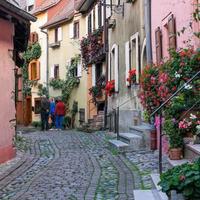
[119,133,144,151]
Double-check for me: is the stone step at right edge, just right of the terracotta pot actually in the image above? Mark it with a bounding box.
[184,144,200,160]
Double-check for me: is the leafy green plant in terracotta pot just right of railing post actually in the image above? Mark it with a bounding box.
[164,119,183,160]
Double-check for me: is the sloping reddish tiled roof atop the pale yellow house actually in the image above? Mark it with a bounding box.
[42,0,74,28]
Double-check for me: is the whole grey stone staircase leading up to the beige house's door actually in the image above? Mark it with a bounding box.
[109,123,153,152]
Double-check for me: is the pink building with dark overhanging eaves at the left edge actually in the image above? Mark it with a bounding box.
[0,0,36,163]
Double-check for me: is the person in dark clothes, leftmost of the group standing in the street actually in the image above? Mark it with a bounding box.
[40,95,50,131]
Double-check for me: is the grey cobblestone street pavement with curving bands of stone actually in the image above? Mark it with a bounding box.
[0,131,137,200]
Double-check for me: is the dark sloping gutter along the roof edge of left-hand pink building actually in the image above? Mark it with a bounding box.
[0,1,37,22]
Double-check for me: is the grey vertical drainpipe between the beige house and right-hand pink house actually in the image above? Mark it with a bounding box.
[144,0,153,64]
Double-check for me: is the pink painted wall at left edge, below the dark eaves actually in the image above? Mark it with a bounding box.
[0,19,15,163]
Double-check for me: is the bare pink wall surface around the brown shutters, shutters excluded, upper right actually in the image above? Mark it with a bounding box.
[151,0,200,62]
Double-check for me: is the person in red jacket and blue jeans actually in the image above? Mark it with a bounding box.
[55,99,66,129]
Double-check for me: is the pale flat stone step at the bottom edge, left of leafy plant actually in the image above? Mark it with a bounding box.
[133,190,165,200]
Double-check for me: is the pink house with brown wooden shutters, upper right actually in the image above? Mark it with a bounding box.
[151,0,200,63]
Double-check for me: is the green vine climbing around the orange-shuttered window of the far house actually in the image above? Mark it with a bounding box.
[22,43,42,96]
